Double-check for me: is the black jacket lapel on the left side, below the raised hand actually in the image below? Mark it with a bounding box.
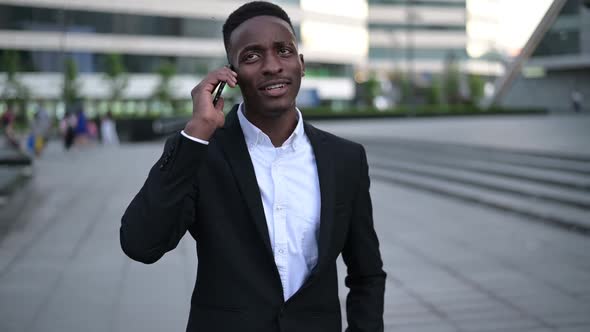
[216,105,274,261]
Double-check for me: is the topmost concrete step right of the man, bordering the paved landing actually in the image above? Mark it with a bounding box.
[361,139,590,176]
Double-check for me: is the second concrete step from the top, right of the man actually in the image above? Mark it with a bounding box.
[367,146,590,192]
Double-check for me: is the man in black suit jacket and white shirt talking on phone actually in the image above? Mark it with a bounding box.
[121,2,385,332]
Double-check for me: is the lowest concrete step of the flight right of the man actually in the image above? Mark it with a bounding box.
[370,167,590,233]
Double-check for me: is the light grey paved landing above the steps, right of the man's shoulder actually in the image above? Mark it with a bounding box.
[318,114,590,156]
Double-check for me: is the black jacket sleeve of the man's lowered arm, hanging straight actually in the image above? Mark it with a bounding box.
[342,148,386,332]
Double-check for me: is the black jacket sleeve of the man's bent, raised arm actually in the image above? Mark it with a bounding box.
[120,133,208,264]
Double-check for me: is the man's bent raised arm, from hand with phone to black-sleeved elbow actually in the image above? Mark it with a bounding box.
[120,68,237,264]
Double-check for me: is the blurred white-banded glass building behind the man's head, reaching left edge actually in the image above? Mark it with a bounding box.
[0,0,360,99]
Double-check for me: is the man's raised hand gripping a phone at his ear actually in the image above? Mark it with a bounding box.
[184,67,238,140]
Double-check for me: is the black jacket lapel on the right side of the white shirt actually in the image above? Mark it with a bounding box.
[305,123,334,280]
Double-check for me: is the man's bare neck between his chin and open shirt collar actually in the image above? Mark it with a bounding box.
[243,104,297,147]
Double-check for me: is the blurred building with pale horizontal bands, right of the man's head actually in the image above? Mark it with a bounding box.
[368,0,467,73]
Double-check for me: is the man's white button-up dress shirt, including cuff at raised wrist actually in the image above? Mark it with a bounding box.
[182,104,321,301]
